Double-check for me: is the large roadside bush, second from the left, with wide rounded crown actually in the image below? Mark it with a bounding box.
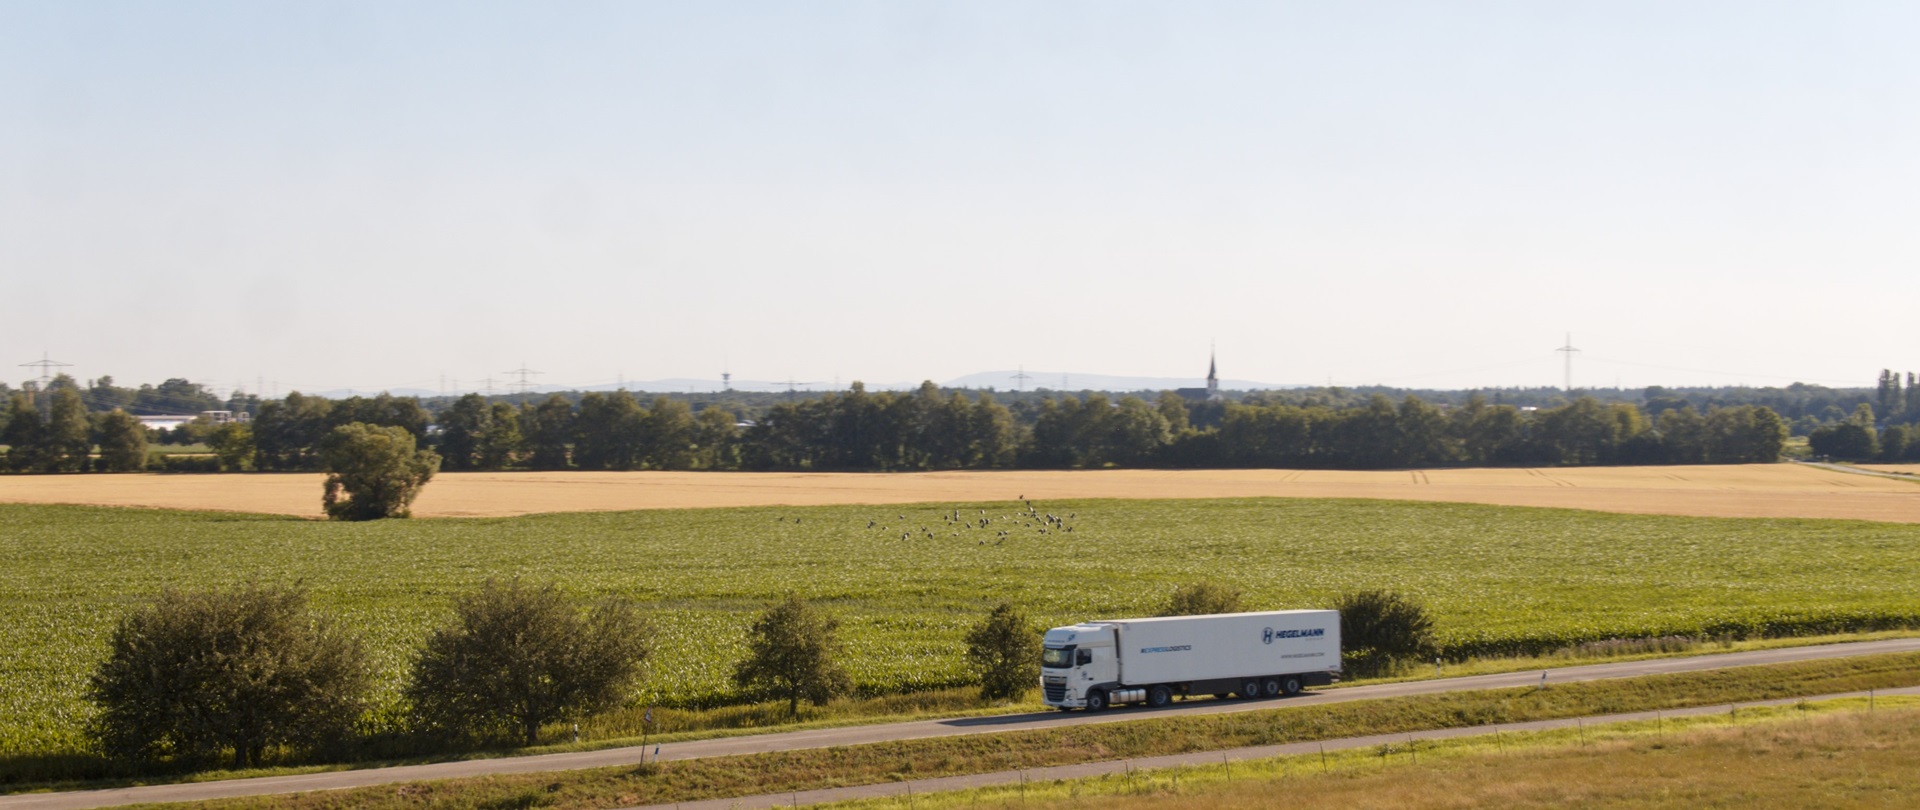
[405,580,653,745]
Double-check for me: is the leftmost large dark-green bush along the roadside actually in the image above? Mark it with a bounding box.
[86,585,372,768]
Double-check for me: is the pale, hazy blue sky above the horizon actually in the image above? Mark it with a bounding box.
[0,0,1920,393]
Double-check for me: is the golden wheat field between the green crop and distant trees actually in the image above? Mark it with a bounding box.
[0,465,1920,522]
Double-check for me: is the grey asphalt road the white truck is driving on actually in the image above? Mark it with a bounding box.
[11,639,1920,810]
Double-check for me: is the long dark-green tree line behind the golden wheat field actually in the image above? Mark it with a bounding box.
[0,382,1804,472]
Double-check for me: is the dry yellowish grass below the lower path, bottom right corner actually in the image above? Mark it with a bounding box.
[821,699,1920,810]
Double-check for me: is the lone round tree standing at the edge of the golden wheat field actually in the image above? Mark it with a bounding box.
[321,422,440,520]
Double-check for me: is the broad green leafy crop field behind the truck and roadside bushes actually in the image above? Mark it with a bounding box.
[0,499,1920,754]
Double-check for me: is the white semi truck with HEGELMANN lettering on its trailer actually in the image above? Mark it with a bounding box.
[1041,610,1340,712]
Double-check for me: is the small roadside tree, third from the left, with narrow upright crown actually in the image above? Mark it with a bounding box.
[733,593,852,718]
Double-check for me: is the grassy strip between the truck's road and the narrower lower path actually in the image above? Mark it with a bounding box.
[116,655,1920,810]
